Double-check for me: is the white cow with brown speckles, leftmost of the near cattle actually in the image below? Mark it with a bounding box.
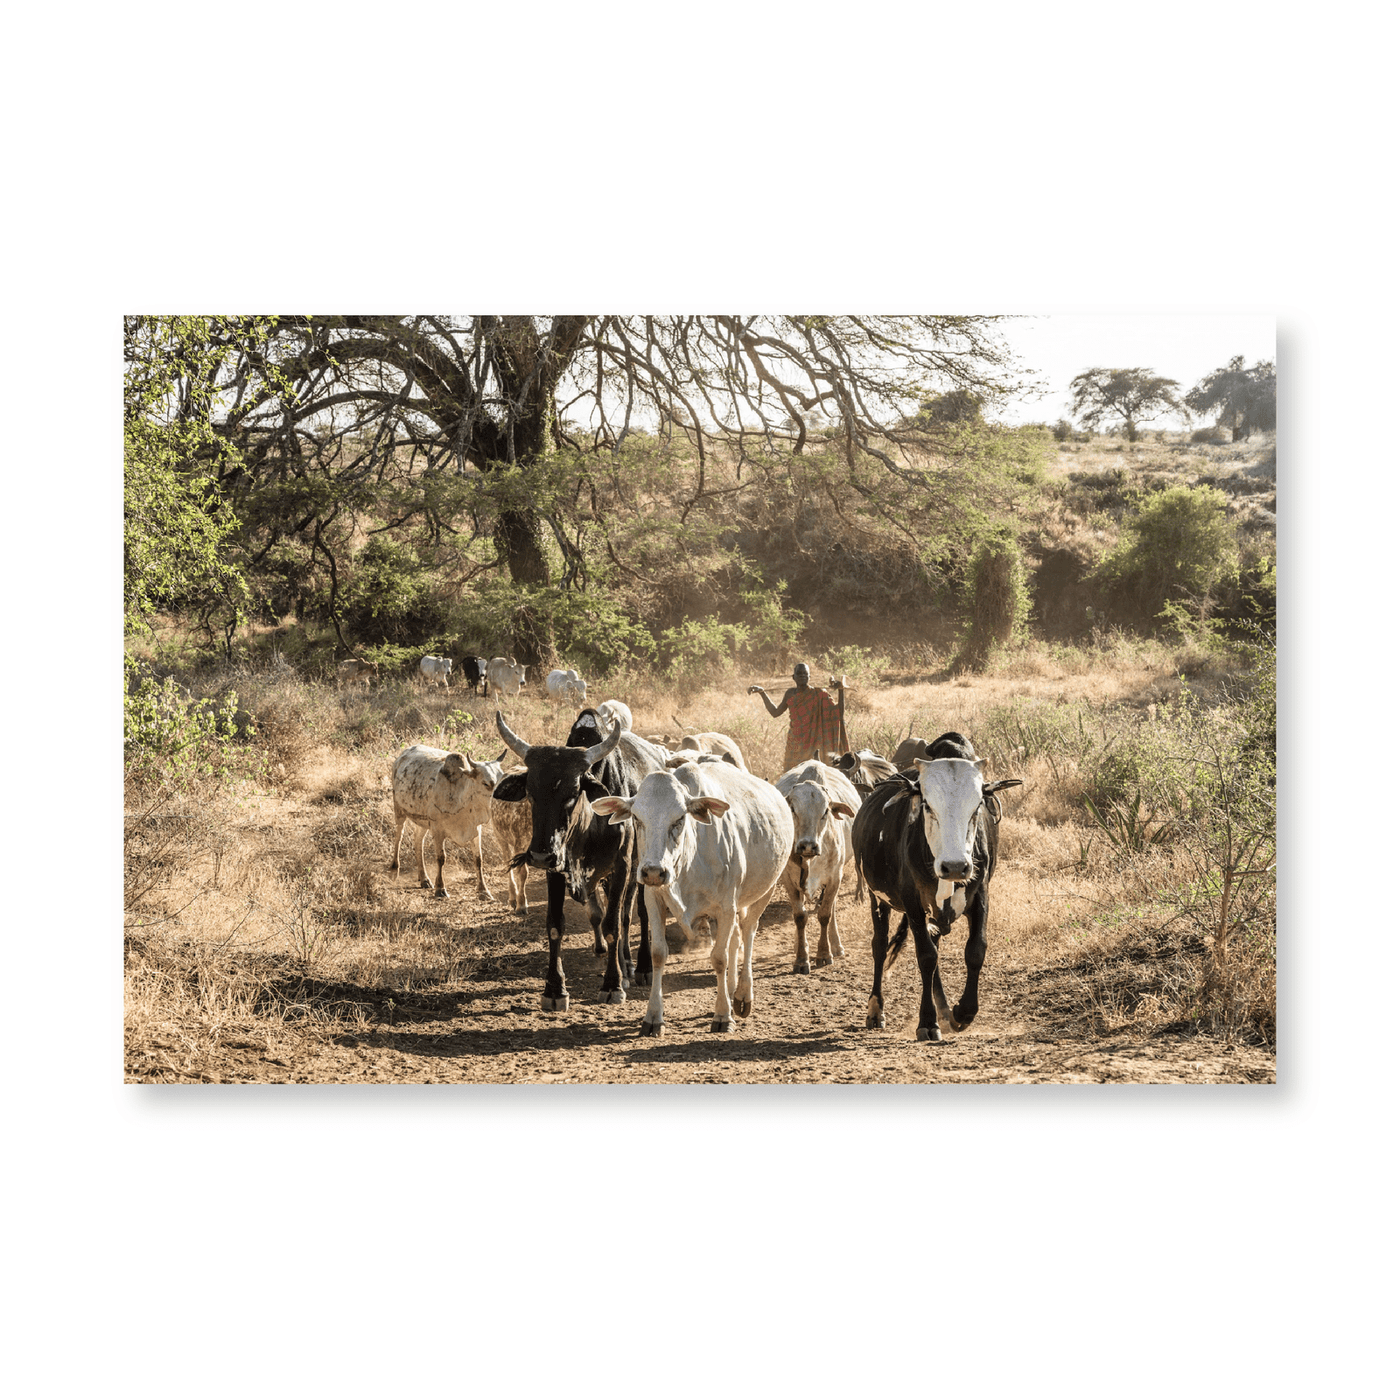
[389,743,505,899]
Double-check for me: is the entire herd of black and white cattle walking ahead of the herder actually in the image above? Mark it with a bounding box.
[383,694,1021,1040]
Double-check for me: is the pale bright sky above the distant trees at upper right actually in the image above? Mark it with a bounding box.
[993,312,1275,428]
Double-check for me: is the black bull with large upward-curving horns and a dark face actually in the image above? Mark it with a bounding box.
[494,707,665,1011]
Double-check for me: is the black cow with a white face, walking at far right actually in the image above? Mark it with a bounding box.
[851,731,1021,1040]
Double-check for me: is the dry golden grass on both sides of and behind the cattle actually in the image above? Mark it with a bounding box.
[126,638,1273,1077]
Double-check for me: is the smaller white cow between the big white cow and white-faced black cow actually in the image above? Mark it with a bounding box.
[773,759,861,972]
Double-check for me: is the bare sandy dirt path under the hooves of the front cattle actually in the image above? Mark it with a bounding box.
[127,865,1274,1084]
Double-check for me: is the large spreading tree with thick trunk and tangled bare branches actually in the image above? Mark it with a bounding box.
[131,315,1016,666]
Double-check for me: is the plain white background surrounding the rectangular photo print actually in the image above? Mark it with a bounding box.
[0,0,1396,1397]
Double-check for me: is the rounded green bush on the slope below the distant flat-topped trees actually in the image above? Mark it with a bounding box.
[1091,486,1239,620]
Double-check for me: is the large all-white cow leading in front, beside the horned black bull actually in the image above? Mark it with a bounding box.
[592,763,792,1036]
